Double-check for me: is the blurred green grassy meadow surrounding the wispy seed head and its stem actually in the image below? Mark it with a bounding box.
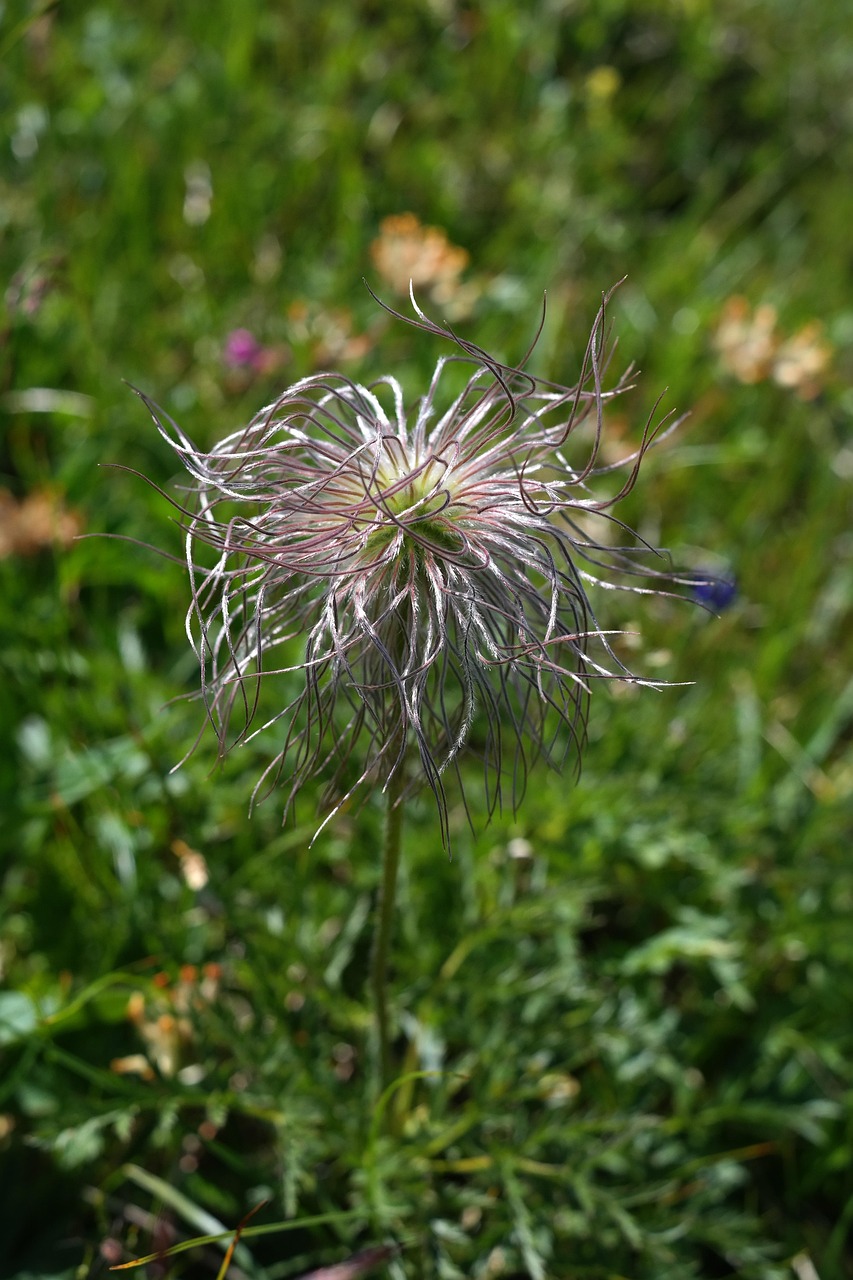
[0,0,853,1280]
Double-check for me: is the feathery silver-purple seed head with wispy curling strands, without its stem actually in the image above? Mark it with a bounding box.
[142,294,693,842]
